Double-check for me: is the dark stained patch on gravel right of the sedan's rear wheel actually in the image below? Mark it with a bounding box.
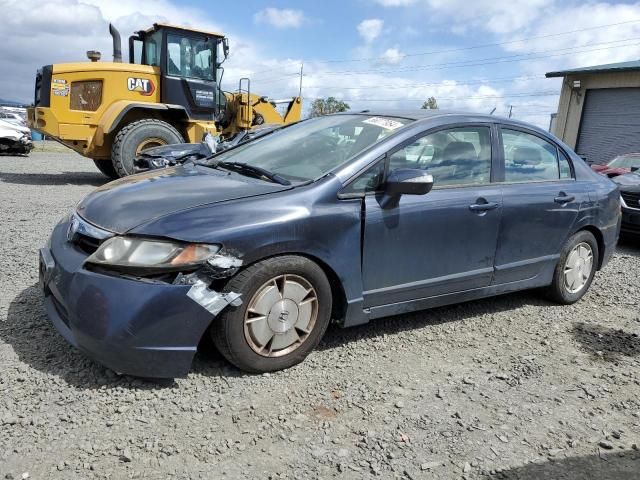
[573,323,640,362]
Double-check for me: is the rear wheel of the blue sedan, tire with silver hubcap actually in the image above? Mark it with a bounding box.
[547,230,599,305]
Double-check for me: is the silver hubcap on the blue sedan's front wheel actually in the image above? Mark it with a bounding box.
[244,275,318,357]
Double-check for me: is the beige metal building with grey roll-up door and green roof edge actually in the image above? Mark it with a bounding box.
[546,60,640,163]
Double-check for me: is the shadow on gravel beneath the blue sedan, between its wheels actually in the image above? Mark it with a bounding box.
[317,290,554,350]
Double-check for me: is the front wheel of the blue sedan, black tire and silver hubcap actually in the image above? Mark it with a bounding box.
[210,255,332,373]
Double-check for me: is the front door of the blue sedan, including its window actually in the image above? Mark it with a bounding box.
[362,125,502,308]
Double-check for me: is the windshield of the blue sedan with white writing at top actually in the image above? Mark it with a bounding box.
[210,115,411,182]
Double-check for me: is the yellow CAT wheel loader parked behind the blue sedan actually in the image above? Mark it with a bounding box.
[27,23,302,178]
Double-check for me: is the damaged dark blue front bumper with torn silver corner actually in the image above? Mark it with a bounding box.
[40,221,241,378]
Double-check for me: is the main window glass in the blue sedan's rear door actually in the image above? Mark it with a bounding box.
[502,128,560,182]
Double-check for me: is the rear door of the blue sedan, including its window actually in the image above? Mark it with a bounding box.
[493,126,589,284]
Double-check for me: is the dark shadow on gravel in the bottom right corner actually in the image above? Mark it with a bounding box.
[481,450,640,480]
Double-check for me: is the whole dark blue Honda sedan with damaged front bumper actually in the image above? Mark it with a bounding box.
[40,111,620,377]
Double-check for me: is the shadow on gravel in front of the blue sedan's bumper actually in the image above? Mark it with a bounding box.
[0,284,176,390]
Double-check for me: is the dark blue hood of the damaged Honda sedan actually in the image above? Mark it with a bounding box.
[77,164,292,233]
